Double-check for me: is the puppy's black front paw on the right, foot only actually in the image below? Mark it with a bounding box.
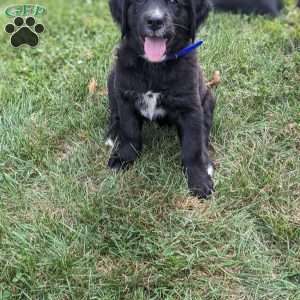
[189,172,214,199]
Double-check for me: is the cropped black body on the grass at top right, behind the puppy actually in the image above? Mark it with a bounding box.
[212,0,283,17]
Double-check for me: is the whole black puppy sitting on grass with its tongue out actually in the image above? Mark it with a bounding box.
[107,0,215,197]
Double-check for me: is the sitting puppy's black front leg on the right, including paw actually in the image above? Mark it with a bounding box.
[178,108,213,198]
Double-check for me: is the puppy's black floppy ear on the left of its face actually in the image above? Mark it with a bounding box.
[109,0,129,37]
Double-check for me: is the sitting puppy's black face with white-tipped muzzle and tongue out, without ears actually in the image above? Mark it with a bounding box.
[133,0,191,63]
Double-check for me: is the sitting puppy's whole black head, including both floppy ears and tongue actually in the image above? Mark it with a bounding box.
[110,0,210,63]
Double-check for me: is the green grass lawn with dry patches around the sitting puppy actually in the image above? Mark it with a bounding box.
[0,0,300,300]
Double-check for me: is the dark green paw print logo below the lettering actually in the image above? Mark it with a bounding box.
[5,17,45,48]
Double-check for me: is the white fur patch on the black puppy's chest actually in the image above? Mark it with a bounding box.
[140,91,166,121]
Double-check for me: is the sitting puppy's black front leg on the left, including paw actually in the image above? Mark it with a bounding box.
[108,97,142,171]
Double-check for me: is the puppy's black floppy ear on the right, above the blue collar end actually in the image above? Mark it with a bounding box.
[190,0,212,40]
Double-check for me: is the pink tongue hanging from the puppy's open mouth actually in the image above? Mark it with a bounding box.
[144,37,167,62]
